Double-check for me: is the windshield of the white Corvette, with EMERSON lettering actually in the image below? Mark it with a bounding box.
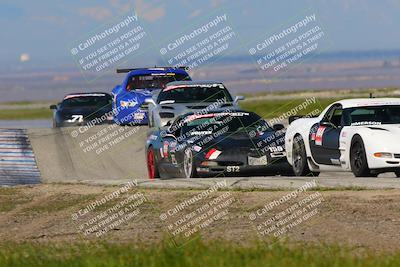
[343,105,400,126]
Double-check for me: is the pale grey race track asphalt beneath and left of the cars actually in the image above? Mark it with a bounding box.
[20,125,400,189]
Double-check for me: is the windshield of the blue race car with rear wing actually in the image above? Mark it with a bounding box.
[126,73,190,91]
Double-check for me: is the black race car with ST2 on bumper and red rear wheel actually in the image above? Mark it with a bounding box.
[146,110,293,179]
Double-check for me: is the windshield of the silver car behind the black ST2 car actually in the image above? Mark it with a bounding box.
[157,84,232,103]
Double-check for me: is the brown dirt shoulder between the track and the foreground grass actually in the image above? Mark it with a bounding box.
[0,184,400,251]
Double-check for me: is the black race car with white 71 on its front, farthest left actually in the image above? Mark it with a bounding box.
[50,93,113,127]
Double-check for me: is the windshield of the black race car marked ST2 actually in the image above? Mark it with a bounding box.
[182,112,273,136]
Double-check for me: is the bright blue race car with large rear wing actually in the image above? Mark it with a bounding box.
[112,67,191,125]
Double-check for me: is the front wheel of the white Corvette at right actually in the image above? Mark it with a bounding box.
[350,136,376,177]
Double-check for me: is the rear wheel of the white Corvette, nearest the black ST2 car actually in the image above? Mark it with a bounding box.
[292,136,319,176]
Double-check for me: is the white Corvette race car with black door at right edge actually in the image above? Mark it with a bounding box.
[285,98,400,177]
